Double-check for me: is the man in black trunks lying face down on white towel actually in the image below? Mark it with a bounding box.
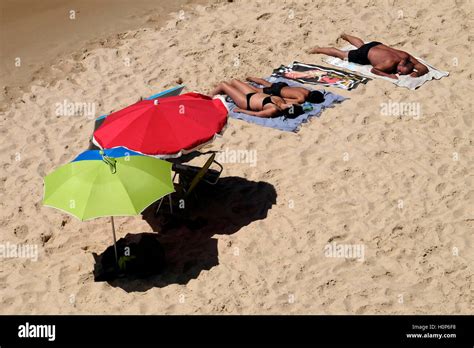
[308,34,428,79]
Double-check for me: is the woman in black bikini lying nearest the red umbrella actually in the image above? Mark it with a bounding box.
[211,79,304,118]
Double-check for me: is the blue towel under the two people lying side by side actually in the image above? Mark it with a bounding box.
[226,77,347,132]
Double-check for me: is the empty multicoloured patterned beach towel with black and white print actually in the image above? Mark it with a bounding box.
[272,62,370,90]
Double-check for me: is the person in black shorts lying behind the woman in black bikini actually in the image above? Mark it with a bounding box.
[247,77,324,104]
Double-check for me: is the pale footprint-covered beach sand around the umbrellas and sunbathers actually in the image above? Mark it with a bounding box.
[0,0,474,314]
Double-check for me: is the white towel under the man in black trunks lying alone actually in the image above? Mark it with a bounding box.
[323,45,449,89]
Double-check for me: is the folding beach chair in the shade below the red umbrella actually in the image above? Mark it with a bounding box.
[155,153,224,216]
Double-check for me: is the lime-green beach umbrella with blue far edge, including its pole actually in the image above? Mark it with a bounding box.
[43,148,174,259]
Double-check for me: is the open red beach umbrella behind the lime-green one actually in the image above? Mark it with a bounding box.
[93,93,228,157]
